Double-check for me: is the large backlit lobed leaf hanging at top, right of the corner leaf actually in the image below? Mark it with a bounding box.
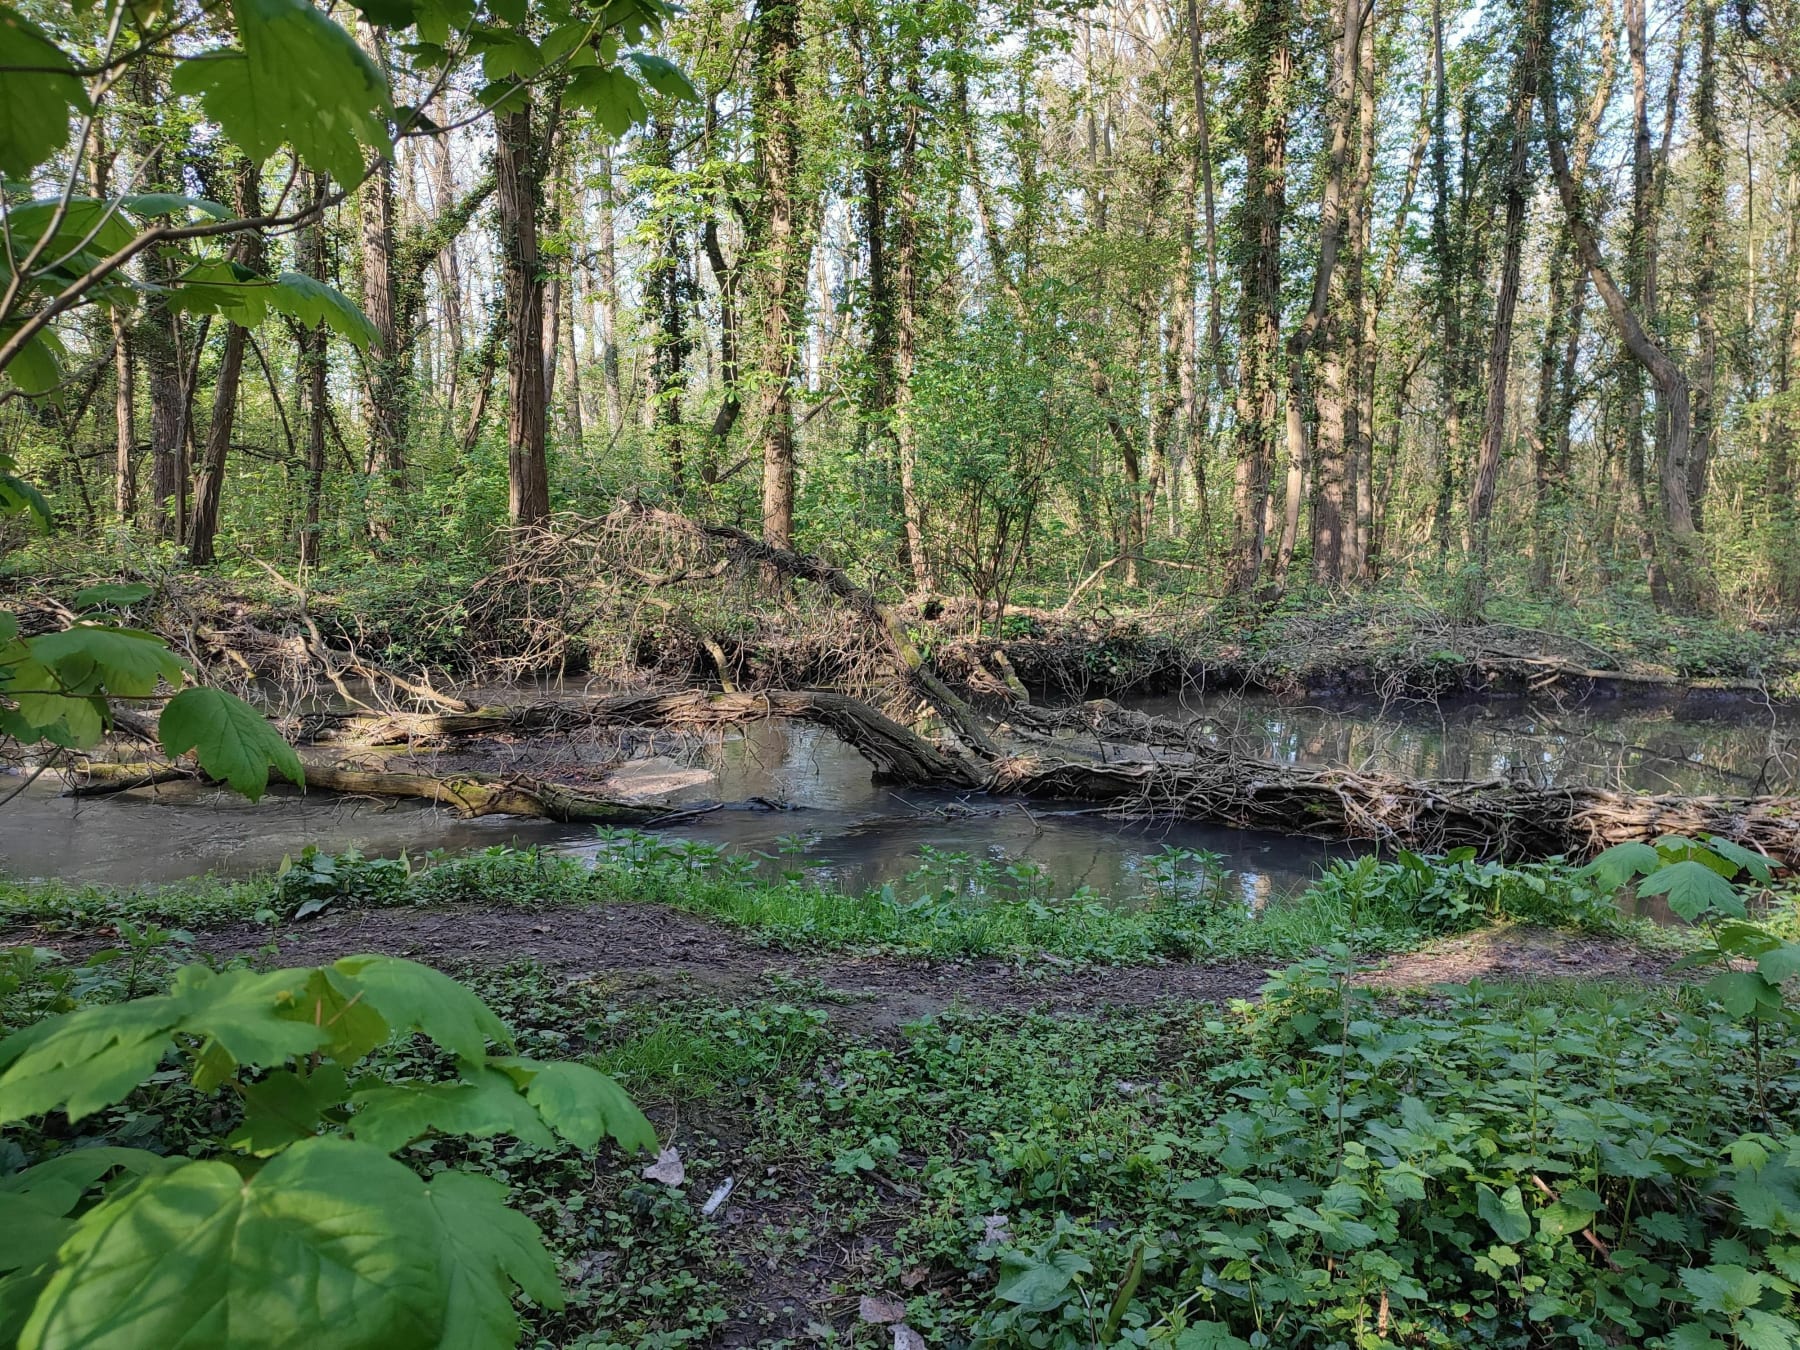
[171,0,392,184]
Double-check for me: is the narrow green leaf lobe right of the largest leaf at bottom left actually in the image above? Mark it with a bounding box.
[425,1172,563,1350]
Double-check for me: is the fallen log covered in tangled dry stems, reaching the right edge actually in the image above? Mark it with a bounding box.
[986,751,1800,868]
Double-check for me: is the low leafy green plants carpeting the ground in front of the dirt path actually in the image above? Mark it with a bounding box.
[4,914,1800,1350]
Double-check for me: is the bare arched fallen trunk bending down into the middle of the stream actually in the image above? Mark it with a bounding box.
[310,689,981,788]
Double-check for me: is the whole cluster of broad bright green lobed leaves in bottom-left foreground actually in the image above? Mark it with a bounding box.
[0,956,655,1350]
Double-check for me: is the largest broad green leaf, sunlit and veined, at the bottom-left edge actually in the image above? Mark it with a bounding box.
[20,1139,448,1350]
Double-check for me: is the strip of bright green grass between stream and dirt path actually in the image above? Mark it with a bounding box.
[0,832,1649,965]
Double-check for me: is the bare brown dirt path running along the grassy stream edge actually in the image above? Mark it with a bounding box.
[4,904,1669,1031]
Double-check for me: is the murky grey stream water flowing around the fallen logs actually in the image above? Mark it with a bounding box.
[0,691,1800,905]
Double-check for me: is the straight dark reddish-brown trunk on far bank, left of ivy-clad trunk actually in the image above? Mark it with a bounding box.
[493,92,551,526]
